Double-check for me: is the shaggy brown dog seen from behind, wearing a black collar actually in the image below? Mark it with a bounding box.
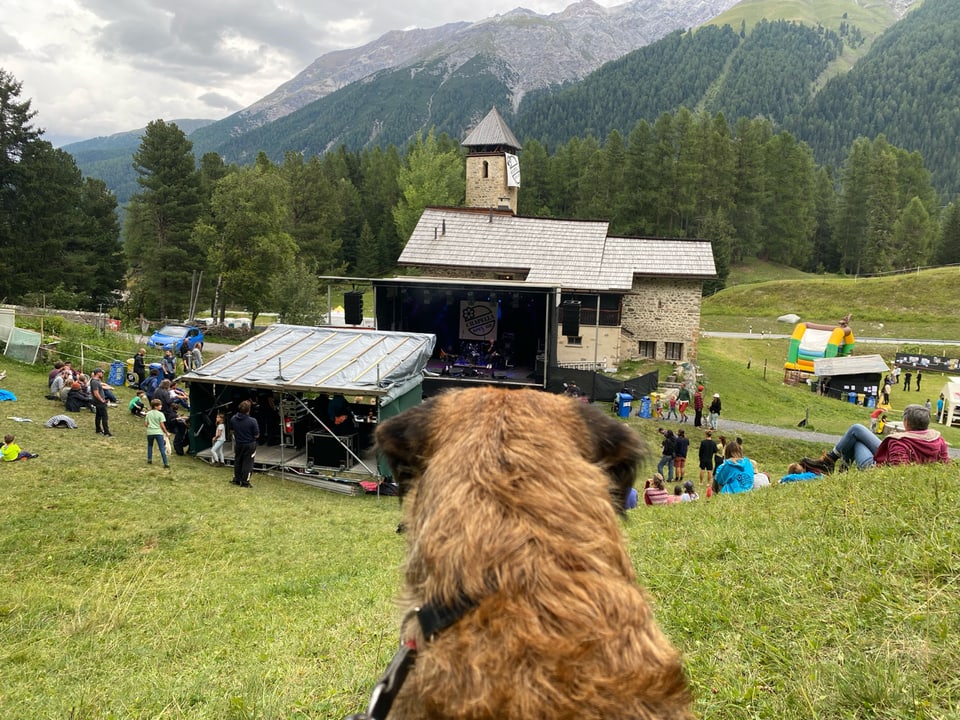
[377,388,692,720]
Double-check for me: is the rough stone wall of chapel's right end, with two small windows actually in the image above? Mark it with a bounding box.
[620,278,702,362]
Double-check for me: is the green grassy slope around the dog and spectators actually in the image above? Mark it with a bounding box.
[0,268,960,720]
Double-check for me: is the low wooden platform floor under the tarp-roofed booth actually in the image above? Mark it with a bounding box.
[196,443,382,495]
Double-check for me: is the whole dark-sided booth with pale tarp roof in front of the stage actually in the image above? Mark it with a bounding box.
[182,325,436,494]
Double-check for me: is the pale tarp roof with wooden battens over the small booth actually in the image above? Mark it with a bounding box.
[183,324,436,405]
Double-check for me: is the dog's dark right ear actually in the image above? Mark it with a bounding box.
[576,403,647,514]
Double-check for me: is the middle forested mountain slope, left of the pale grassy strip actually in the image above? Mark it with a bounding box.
[515,20,843,147]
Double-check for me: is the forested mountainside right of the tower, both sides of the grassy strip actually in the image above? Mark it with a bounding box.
[512,0,960,194]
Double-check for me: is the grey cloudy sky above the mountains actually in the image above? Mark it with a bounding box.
[0,0,617,145]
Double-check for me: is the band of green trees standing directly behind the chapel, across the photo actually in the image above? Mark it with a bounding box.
[7,61,960,323]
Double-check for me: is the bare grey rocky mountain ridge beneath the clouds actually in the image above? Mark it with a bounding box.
[225,0,737,133]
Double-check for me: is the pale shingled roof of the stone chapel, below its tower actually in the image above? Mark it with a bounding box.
[399,208,717,292]
